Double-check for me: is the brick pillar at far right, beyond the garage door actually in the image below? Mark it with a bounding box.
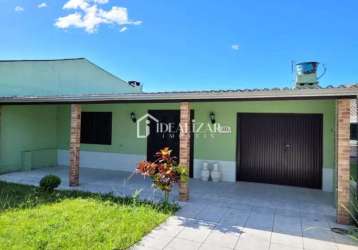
[336,99,351,224]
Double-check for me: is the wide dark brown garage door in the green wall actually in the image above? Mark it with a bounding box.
[237,113,322,188]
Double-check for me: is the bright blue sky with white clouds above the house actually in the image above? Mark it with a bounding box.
[0,0,358,91]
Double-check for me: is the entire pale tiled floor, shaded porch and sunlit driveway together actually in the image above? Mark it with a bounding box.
[0,167,358,250]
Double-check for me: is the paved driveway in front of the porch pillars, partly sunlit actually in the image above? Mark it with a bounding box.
[134,202,358,250]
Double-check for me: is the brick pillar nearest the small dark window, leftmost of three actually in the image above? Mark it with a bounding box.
[69,104,81,186]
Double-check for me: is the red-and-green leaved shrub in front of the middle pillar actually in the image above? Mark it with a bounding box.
[136,147,186,202]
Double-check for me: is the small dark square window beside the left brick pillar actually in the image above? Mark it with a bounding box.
[81,112,112,145]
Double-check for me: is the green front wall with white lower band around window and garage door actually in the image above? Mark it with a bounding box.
[57,100,336,191]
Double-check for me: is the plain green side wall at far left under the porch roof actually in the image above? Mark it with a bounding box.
[0,105,57,173]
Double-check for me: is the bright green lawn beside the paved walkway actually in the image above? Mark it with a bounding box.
[0,182,177,250]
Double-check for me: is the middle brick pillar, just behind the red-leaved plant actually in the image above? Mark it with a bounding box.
[179,102,191,201]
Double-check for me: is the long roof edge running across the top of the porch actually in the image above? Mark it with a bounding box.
[0,88,358,104]
